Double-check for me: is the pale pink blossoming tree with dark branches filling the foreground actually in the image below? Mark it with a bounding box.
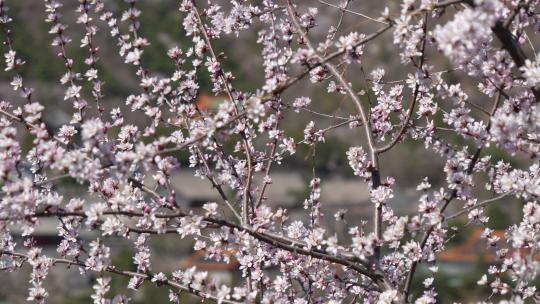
[0,0,540,303]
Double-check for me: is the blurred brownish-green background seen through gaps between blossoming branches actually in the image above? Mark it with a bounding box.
[0,0,532,304]
